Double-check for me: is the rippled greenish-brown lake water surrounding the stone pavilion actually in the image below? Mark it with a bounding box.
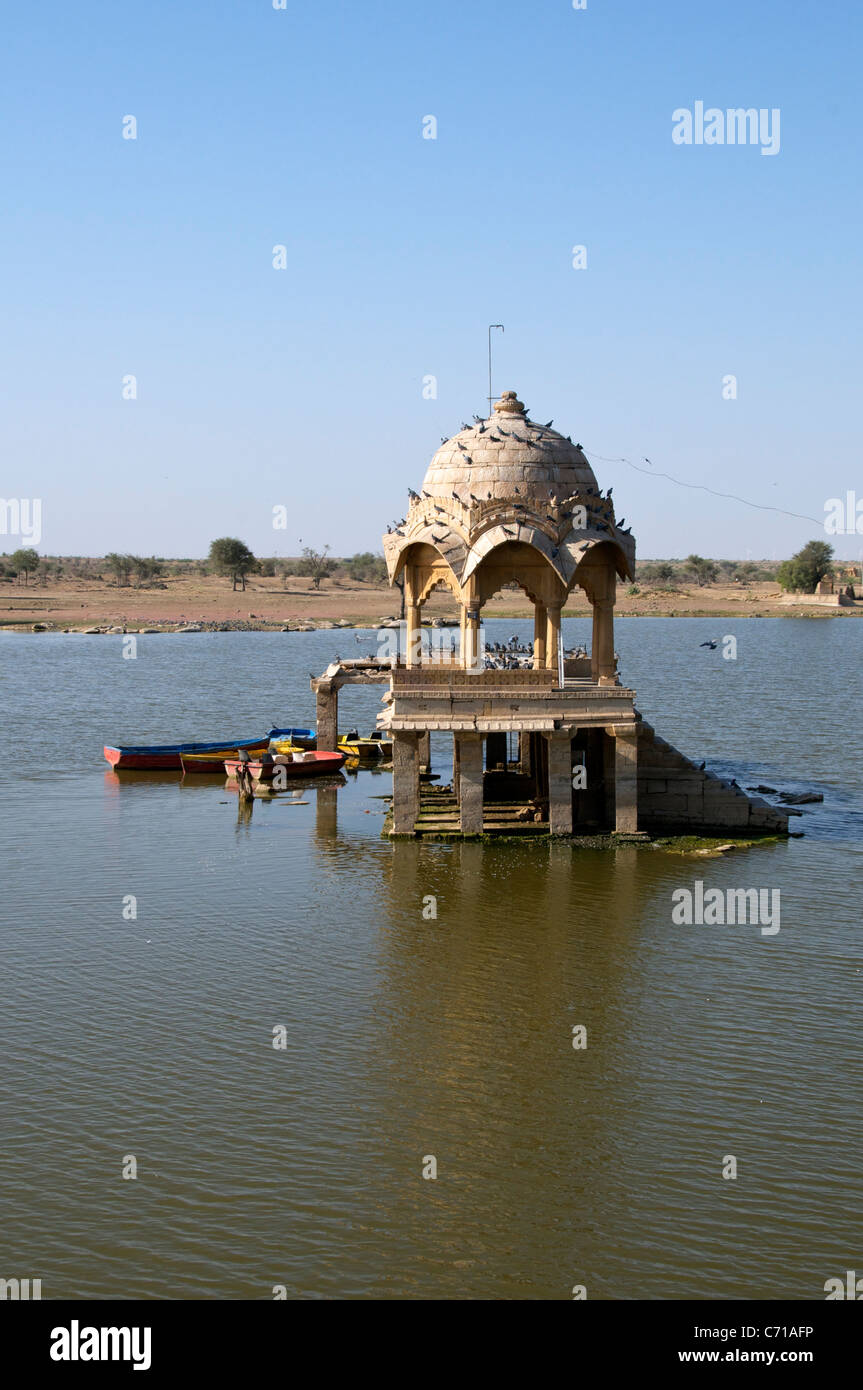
[0,619,863,1298]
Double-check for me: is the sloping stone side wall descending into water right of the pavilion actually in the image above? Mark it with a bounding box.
[638,719,788,834]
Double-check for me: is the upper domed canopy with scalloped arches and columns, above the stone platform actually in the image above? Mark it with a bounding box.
[384,391,635,685]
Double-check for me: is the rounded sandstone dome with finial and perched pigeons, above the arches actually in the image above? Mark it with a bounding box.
[422,391,596,503]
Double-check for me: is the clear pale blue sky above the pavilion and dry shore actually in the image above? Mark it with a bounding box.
[0,0,863,557]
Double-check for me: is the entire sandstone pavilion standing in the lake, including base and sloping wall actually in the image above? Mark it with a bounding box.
[311,391,788,840]
